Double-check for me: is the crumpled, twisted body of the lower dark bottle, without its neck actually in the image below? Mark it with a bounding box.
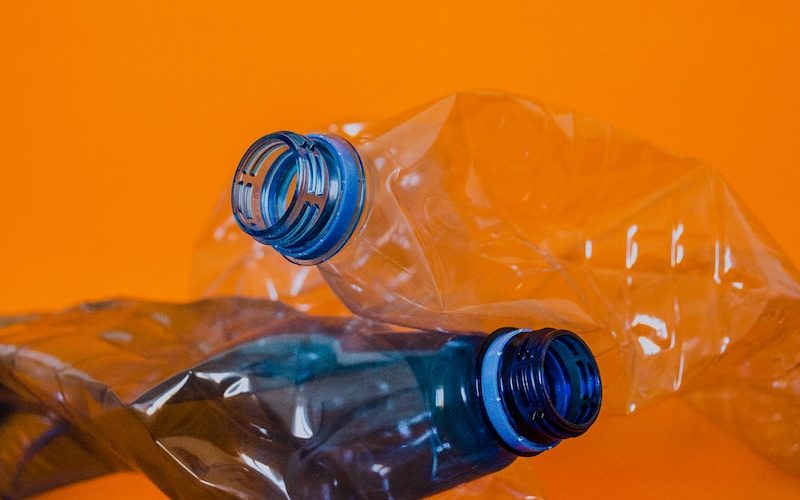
[0,298,568,498]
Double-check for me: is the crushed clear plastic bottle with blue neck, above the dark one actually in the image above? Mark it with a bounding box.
[232,92,800,412]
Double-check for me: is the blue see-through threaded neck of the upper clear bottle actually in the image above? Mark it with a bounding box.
[231,132,366,265]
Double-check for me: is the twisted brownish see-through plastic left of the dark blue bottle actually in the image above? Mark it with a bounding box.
[0,299,298,498]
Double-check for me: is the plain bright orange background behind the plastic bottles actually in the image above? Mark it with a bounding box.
[0,0,800,499]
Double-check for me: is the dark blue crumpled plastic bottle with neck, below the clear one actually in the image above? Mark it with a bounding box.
[142,319,601,499]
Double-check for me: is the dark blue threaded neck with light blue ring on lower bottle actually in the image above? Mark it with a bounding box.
[478,328,602,456]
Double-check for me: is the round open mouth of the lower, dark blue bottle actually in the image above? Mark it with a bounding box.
[542,332,602,430]
